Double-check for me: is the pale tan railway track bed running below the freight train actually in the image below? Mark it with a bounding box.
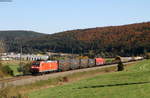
[0,61,141,88]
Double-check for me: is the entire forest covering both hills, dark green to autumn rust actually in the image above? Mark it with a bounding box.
[0,22,150,57]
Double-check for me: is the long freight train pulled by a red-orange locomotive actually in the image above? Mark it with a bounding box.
[30,57,143,74]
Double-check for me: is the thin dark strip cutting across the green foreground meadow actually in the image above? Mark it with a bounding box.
[78,81,150,89]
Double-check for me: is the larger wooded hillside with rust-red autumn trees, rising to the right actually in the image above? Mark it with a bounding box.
[26,22,150,56]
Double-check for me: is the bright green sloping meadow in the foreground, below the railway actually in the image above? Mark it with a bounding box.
[28,60,150,98]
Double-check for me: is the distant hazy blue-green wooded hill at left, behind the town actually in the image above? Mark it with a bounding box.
[0,30,46,52]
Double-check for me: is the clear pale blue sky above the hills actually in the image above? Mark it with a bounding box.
[0,0,150,34]
